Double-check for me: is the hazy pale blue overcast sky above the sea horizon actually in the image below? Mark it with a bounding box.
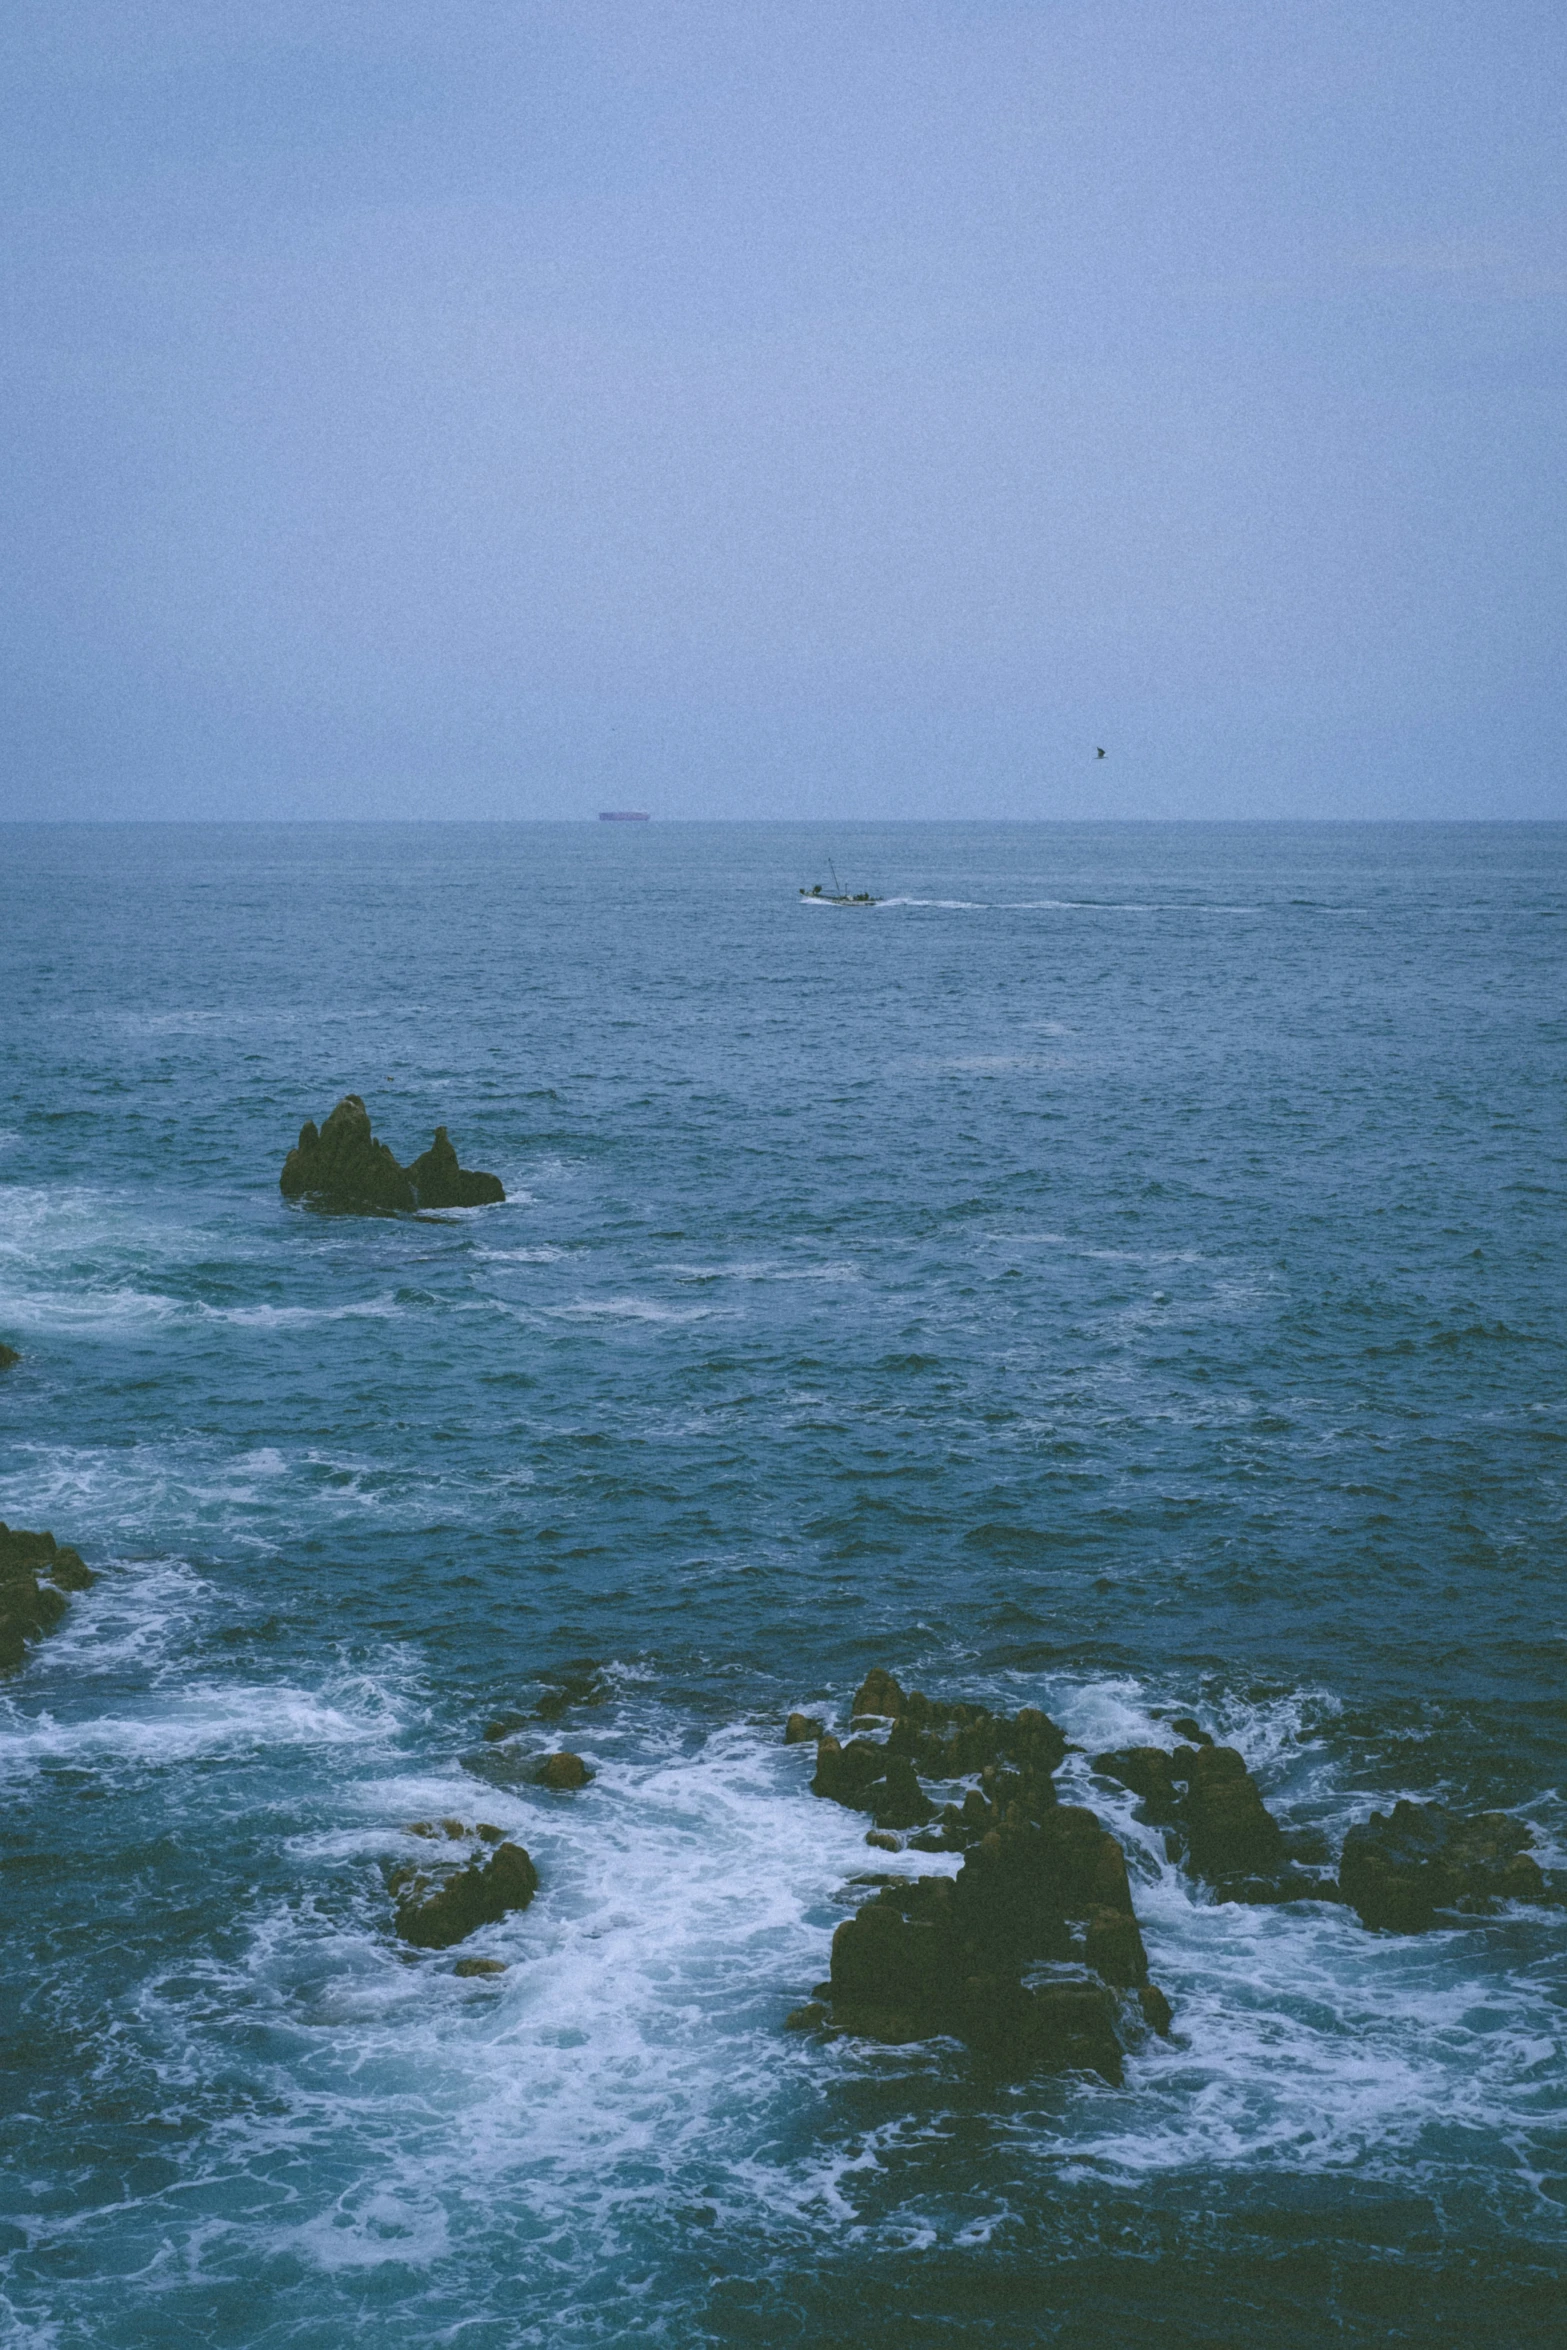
[0,0,1567,820]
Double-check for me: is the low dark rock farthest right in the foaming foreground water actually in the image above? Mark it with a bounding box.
[1339,1802,1546,1934]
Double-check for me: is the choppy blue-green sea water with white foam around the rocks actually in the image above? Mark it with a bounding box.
[0,825,1567,2350]
